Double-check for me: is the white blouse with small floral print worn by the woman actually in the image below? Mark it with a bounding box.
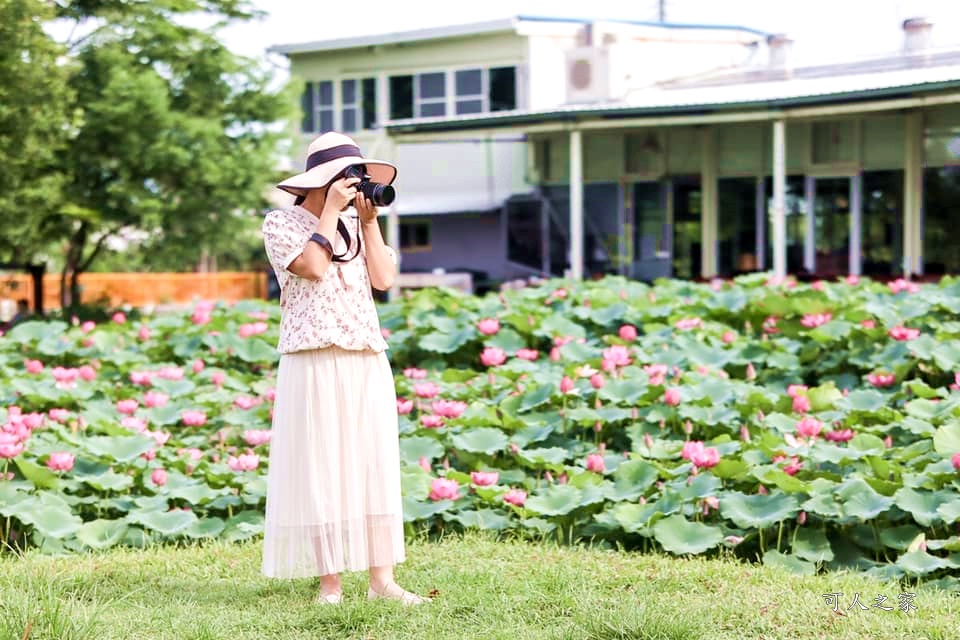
[261,206,397,353]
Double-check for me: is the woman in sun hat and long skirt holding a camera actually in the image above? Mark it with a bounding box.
[262,132,429,604]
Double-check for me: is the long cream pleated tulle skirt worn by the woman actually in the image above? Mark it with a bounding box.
[262,347,405,578]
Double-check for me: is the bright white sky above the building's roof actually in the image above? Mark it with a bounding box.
[222,0,960,75]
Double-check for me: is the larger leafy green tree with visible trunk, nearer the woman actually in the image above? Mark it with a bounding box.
[48,0,295,307]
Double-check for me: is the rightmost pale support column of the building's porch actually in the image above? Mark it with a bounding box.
[903,111,923,278]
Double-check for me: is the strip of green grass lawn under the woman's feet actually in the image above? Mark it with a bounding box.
[0,533,960,640]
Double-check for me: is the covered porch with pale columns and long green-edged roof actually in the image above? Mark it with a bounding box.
[389,84,960,280]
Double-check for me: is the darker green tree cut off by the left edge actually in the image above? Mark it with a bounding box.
[0,0,73,265]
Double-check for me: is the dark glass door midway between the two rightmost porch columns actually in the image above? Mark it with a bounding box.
[808,177,854,277]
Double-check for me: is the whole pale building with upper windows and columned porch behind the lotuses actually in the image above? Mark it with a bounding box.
[274,17,960,288]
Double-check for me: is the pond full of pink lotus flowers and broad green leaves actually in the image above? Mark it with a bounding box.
[0,274,960,588]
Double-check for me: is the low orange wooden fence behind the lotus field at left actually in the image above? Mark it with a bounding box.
[0,271,267,309]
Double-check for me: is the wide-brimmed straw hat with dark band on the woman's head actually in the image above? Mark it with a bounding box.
[277,131,397,196]
